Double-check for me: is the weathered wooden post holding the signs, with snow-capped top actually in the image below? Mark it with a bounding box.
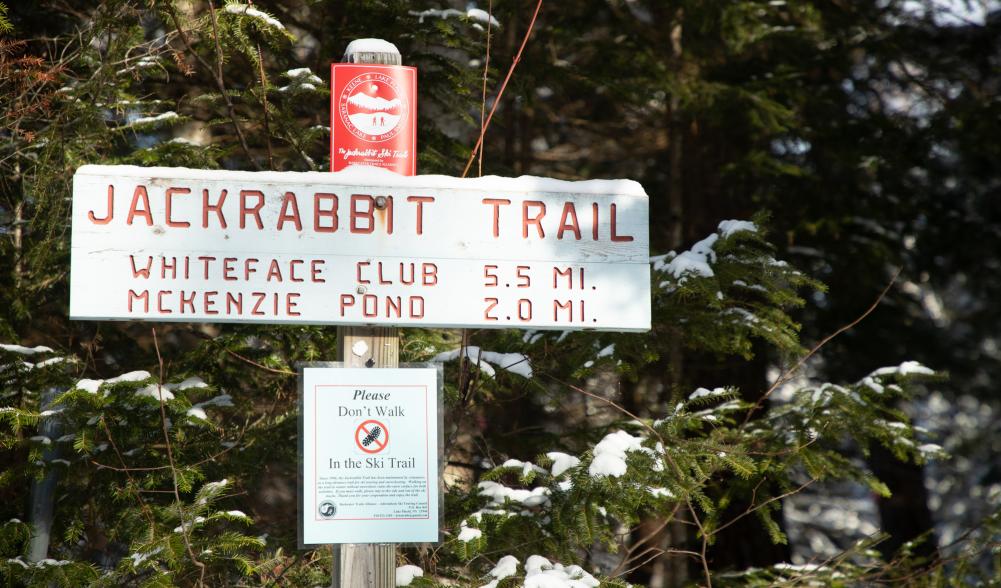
[330,39,403,588]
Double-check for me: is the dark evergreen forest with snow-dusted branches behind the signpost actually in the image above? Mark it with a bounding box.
[0,0,1001,587]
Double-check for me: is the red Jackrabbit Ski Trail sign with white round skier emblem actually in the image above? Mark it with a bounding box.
[330,63,416,175]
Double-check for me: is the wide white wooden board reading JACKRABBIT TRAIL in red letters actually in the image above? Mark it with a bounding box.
[70,165,651,331]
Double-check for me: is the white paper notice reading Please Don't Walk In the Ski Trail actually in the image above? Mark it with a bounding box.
[300,368,438,545]
